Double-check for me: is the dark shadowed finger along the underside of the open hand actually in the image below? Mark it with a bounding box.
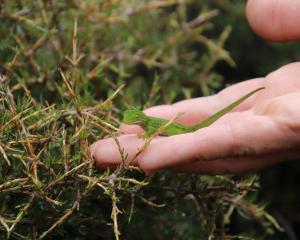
[170,150,300,175]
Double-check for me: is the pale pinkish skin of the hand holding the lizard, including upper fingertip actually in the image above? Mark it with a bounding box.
[91,0,300,174]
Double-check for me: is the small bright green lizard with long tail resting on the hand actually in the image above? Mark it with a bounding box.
[122,87,264,137]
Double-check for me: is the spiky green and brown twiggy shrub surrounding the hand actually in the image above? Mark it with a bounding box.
[0,0,300,240]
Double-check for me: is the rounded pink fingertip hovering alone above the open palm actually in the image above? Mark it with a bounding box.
[247,0,300,41]
